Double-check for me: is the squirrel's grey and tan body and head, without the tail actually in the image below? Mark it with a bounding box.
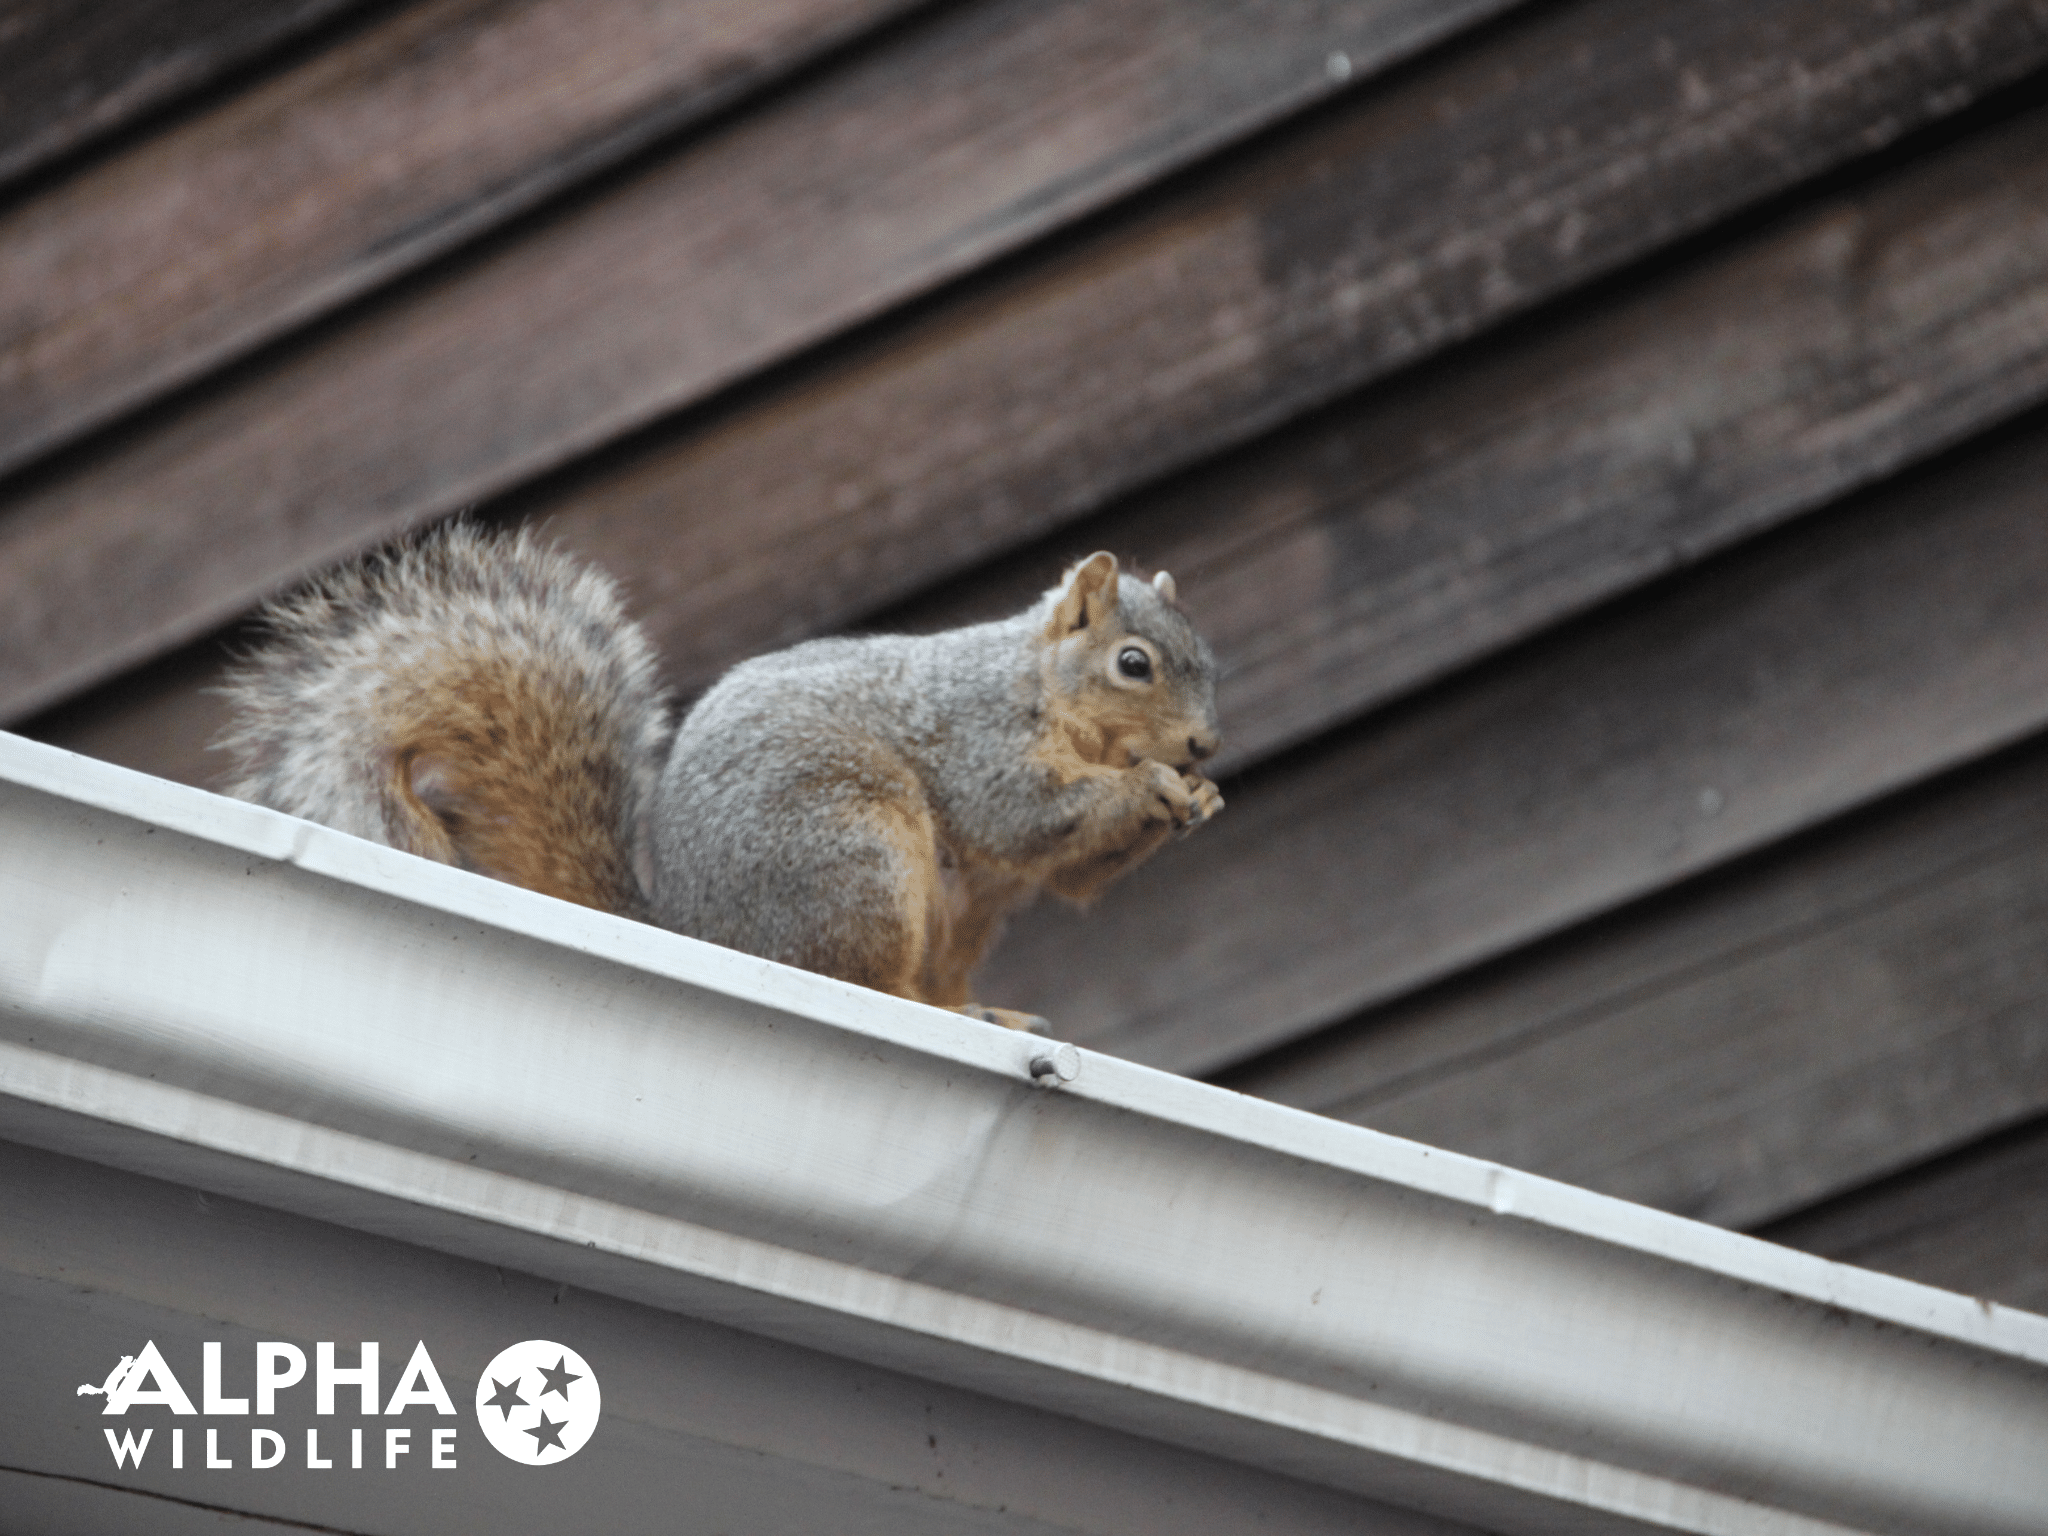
[653,555,1223,1022]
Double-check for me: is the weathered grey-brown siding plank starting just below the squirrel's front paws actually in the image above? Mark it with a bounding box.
[983,424,2048,1071]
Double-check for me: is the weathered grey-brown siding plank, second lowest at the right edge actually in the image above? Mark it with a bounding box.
[1229,741,2048,1227]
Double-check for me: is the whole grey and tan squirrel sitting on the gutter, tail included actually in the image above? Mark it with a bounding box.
[215,520,1223,1032]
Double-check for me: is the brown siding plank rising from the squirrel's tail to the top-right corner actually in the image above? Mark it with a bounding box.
[532,0,2048,686]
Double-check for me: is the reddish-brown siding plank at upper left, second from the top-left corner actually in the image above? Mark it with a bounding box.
[0,0,918,471]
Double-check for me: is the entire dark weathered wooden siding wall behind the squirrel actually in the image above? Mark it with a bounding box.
[12,0,2048,1309]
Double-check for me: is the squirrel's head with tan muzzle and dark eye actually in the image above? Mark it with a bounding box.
[1038,553,1223,768]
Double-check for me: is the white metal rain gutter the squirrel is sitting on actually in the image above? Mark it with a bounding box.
[0,735,2048,1536]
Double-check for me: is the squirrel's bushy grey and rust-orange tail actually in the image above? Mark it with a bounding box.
[217,522,672,915]
